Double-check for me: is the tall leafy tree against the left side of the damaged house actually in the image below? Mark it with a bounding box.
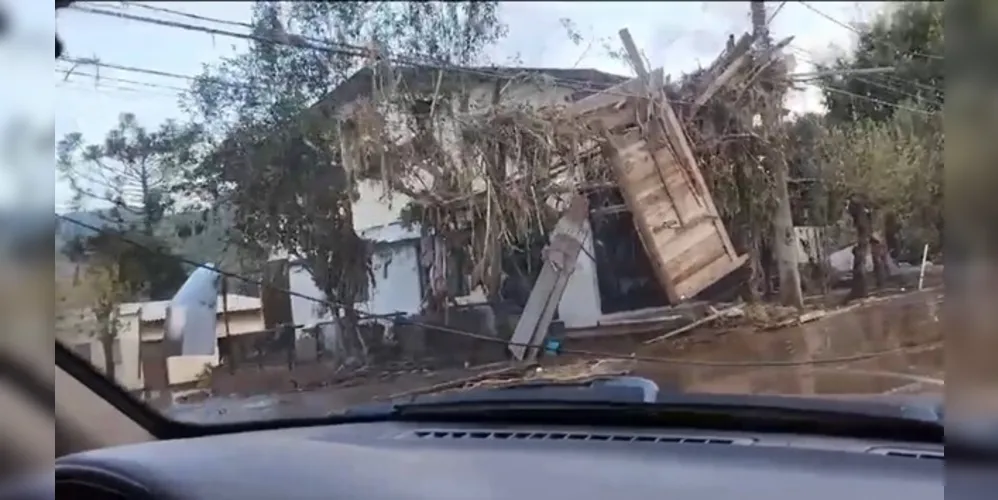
[185,1,505,366]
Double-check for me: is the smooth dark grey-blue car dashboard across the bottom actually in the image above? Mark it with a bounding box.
[50,421,944,500]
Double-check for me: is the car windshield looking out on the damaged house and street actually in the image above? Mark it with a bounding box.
[55,1,944,423]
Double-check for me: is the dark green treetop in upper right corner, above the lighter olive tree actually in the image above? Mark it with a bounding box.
[821,2,945,127]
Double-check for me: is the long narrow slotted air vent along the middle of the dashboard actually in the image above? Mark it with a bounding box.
[402,430,755,445]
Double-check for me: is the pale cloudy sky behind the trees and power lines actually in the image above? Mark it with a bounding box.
[39,1,883,211]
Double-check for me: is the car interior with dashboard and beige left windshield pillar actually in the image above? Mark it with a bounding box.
[15,346,995,500]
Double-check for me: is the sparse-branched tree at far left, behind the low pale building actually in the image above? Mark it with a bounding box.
[56,113,201,305]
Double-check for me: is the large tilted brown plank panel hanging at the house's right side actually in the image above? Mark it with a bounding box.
[570,29,752,304]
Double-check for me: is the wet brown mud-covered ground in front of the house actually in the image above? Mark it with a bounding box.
[163,290,944,423]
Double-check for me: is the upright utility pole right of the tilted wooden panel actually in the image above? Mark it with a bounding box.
[750,0,804,308]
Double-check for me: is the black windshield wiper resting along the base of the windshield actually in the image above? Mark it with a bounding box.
[345,377,943,443]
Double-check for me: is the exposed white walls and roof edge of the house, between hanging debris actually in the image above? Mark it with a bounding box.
[274,64,667,334]
